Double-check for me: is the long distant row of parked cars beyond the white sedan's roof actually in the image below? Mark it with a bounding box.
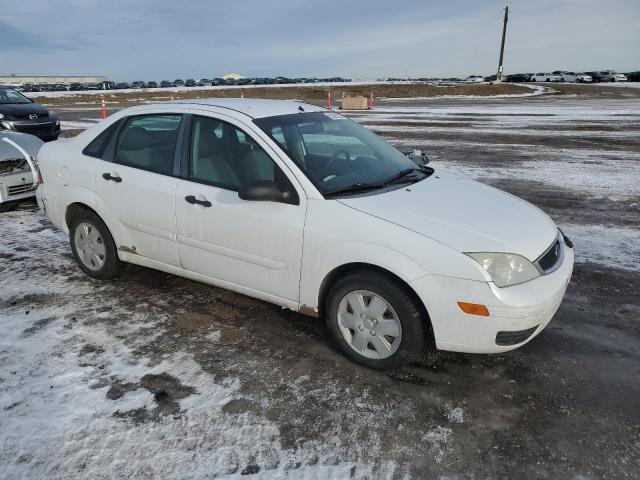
[12,77,351,92]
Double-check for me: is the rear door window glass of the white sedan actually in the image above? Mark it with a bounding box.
[115,114,182,175]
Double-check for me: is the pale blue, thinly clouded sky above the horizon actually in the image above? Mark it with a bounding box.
[0,0,640,81]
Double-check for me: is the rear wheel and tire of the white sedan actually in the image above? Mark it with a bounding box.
[69,210,123,280]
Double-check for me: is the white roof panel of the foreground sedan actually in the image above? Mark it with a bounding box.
[171,98,325,118]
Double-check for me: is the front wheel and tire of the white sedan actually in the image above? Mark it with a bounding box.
[324,270,425,370]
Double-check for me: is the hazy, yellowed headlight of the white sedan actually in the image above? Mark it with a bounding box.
[467,252,540,287]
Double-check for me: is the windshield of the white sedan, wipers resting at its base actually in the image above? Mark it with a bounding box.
[254,111,427,195]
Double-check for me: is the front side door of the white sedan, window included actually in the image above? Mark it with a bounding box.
[176,115,306,307]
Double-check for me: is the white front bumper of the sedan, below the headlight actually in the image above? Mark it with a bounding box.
[411,240,574,353]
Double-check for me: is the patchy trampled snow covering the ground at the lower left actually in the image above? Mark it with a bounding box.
[0,212,398,480]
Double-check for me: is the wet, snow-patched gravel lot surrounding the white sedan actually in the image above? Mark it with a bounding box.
[0,88,640,479]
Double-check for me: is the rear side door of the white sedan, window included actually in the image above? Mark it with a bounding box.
[93,113,182,266]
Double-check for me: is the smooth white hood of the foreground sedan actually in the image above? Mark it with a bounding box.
[339,174,558,261]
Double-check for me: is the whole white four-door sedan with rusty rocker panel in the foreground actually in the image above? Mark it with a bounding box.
[38,99,574,368]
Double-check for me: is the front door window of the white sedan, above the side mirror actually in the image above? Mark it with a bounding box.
[189,116,282,191]
